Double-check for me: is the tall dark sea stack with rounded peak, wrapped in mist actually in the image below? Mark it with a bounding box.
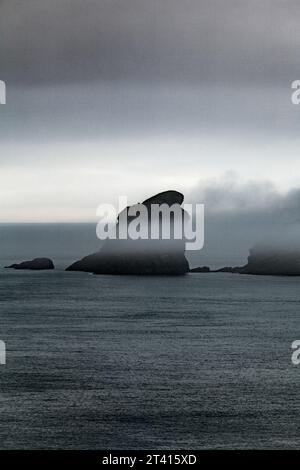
[67,191,189,275]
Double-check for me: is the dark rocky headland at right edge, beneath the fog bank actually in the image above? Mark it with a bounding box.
[239,247,300,276]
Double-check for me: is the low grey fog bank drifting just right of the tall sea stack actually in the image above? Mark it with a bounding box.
[186,177,300,267]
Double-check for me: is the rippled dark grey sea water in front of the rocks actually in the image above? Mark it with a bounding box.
[0,227,300,449]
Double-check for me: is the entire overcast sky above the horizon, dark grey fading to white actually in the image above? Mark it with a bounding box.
[0,0,300,222]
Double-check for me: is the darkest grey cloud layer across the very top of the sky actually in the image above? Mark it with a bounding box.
[0,0,300,85]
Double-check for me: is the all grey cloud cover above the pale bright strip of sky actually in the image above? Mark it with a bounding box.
[0,0,300,147]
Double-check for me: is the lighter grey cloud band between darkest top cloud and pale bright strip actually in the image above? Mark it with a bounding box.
[0,82,300,143]
